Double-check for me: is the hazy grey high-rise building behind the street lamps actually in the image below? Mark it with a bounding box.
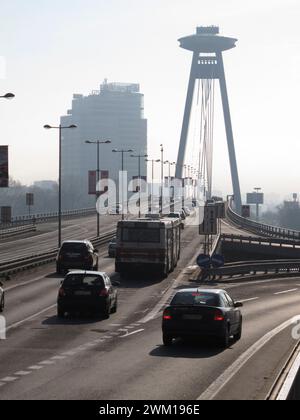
[61,81,147,209]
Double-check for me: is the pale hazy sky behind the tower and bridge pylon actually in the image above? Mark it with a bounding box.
[0,0,300,203]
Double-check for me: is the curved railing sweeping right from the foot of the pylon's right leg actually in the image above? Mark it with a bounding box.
[226,202,300,241]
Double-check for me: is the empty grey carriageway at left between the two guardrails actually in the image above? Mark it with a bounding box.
[0,216,119,262]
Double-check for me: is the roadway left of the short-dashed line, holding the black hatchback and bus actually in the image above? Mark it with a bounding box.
[0,229,204,399]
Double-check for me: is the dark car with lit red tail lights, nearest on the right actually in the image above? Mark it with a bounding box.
[162,288,243,348]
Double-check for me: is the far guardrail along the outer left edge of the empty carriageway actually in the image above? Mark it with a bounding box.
[0,207,96,231]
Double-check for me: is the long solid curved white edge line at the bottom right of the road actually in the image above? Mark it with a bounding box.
[197,317,294,400]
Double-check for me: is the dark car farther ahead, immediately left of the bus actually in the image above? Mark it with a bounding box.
[56,240,99,274]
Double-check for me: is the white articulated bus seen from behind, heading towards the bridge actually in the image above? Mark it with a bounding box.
[116,218,181,277]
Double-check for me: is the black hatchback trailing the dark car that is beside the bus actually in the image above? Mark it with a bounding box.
[57,271,119,318]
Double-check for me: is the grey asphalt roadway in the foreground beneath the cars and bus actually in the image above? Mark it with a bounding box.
[0,221,300,400]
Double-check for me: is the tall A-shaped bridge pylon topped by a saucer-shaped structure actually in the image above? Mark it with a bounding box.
[176,26,242,214]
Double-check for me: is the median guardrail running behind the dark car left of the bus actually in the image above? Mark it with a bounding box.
[0,230,116,277]
